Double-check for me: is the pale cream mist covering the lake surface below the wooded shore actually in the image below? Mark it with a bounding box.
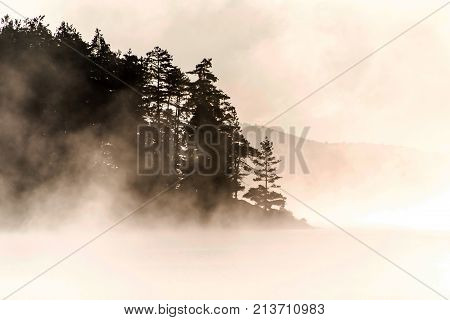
[0,228,450,299]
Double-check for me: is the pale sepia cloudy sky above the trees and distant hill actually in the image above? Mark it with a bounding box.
[0,0,450,151]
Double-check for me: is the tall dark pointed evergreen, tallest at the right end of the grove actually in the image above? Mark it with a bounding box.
[185,59,236,212]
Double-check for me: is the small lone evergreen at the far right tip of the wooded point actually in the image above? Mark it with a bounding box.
[244,137,286,212]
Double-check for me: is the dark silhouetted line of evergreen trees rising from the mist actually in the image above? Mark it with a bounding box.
[0,16,285,220]
